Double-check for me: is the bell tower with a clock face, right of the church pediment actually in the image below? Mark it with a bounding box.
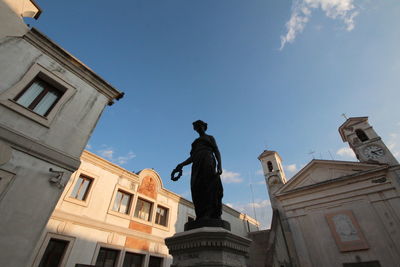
[339,117,399,165]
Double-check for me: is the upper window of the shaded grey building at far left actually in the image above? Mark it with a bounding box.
[14,77,63,116]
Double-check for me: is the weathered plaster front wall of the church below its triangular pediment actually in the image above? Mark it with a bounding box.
[281,172,400,267]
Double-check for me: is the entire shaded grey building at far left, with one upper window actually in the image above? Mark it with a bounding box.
[0,0,123,267]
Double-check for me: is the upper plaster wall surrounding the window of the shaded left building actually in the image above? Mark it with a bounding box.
[0,37,108,158]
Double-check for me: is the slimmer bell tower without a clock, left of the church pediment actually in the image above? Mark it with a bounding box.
[258,150,286,208]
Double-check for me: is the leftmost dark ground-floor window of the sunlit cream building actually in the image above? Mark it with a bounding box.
[39,238,69,267]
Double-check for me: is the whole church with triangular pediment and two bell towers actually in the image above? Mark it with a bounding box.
[259,117,400,267]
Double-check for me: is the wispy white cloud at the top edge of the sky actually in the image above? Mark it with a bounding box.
[280,0,358,50]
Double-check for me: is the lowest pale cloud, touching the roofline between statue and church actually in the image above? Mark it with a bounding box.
[230,199,272,229]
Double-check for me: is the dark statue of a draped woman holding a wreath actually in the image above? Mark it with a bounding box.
[171,120,223,220]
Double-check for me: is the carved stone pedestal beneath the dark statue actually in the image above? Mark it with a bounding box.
[165,227,251,267]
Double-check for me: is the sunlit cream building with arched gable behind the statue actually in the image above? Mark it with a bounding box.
[30,151,259,267]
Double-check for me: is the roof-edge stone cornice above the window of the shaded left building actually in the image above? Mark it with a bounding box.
[23,28,124,105]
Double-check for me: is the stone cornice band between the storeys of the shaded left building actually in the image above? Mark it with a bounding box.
[0,124,81,172]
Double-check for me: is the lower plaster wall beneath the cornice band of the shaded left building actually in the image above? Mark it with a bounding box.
[0,149,71,267]
